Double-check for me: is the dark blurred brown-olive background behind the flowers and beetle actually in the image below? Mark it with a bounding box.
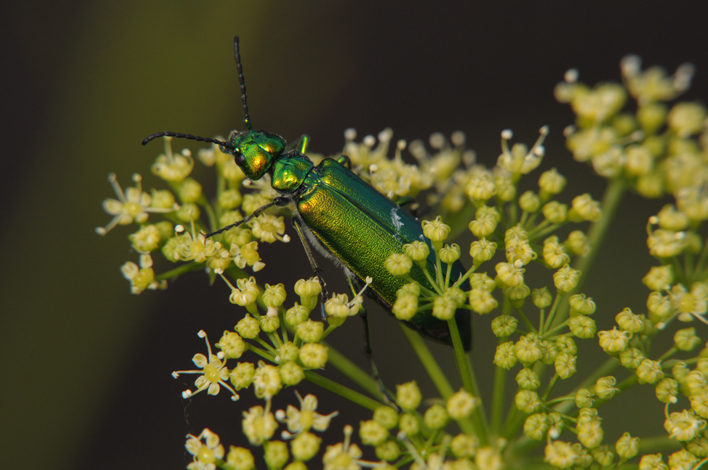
[0,0,708,469]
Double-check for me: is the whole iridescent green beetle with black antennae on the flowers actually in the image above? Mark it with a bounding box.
[143,36,472,350]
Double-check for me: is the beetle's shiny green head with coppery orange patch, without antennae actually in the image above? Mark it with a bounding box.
[221,131,286,181]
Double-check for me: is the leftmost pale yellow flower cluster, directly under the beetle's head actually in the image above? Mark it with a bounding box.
[96,137,289,294]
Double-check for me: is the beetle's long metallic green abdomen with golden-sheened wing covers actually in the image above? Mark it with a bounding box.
[297,159,471,349]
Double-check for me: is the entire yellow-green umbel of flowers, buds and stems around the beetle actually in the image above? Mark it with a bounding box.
[97,56,708,470]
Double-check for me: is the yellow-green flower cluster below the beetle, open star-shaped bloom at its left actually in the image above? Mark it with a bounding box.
[173,270,370,401]
